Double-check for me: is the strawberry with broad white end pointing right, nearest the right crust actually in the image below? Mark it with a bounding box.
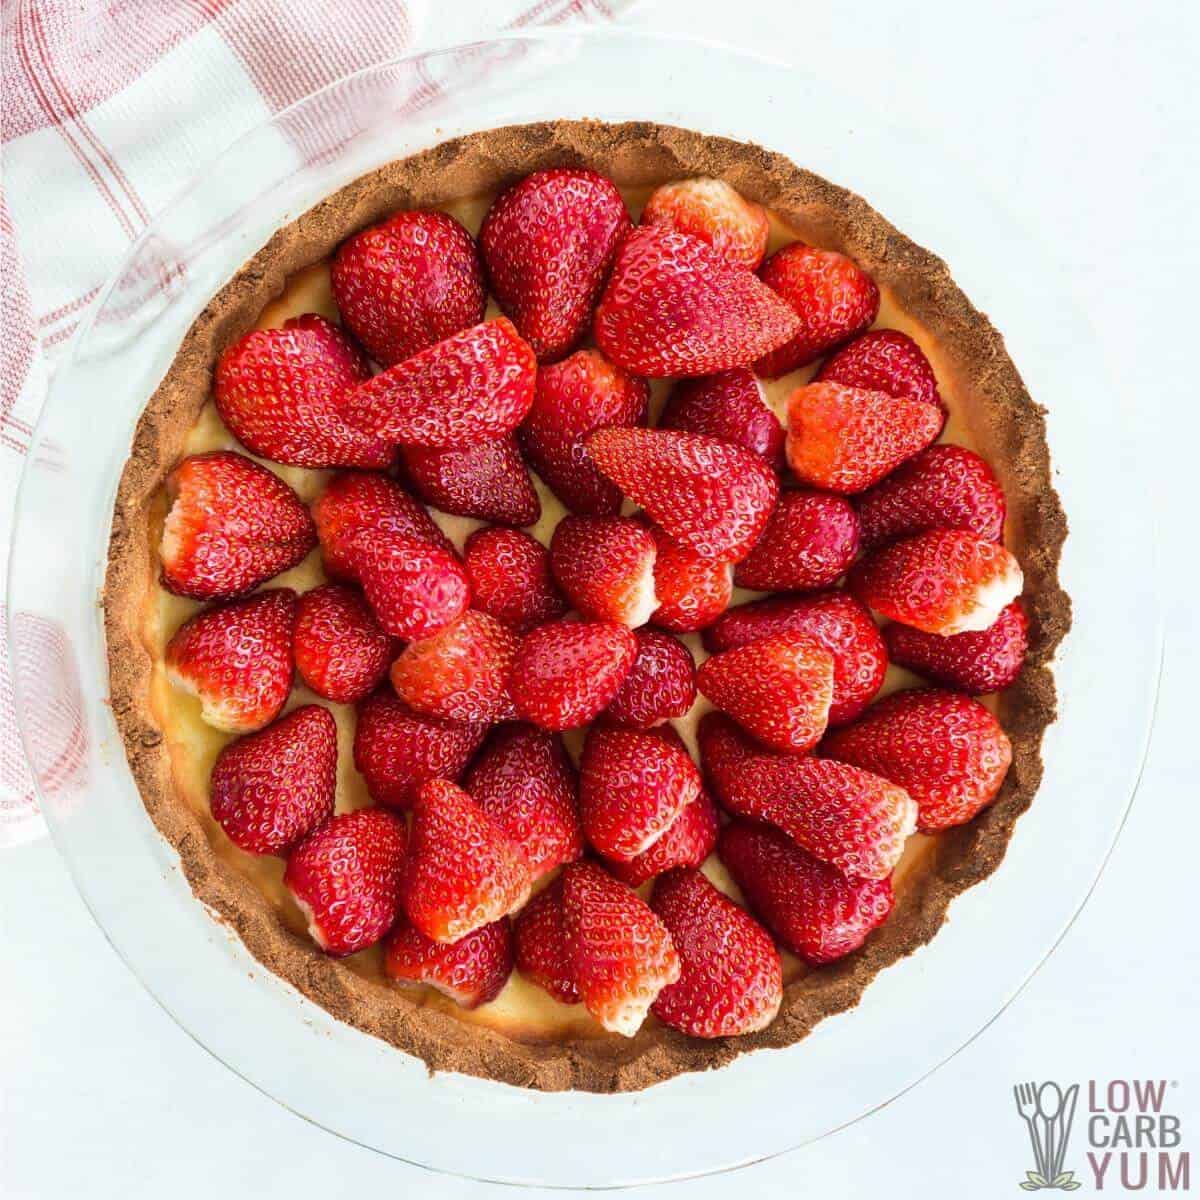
[846,529,1024,636]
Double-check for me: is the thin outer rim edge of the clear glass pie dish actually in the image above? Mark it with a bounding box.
[6,28,1164,1190]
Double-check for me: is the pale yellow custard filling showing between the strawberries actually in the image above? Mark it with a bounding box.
[144,190,995,1042]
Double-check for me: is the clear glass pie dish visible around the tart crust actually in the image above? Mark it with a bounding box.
[10,32,1160,1186]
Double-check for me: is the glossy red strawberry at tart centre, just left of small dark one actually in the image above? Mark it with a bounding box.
[509,620,637,730]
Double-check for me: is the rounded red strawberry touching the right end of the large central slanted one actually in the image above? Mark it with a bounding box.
[733,487,858,592]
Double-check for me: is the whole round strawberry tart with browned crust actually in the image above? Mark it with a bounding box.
[104,121,1070,1091]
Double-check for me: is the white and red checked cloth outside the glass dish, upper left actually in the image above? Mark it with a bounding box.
[0,0,630,846]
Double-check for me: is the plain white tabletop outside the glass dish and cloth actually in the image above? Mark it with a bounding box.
[0,0,1200,1200]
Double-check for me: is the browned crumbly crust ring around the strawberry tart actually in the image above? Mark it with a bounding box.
[104,121,1070,1092]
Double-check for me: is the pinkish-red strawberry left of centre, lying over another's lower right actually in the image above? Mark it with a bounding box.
[349,532,470,641]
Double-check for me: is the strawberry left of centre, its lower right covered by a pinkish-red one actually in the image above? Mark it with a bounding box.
[312,470,454,582]
